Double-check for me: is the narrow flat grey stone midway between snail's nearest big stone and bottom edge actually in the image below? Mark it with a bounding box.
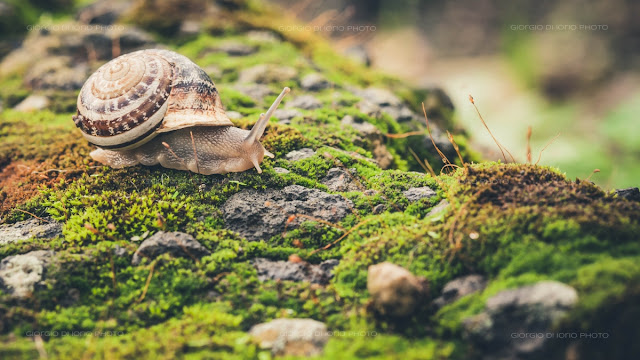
[252,258,338,285]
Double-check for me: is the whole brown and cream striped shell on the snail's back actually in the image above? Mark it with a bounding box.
[73,50,233,150]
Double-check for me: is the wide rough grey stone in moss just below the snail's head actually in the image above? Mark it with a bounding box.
[222,185,353,241]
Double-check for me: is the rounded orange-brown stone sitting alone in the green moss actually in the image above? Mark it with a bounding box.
[367,262,427,318]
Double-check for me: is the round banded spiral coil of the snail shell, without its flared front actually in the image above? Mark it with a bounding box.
[73,51,173,148]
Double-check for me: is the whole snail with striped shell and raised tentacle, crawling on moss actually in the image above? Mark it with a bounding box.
[73,50,289,175]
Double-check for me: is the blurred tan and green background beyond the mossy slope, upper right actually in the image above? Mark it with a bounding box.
[277,0,640,188]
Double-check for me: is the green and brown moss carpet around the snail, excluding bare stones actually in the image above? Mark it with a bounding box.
[0,1,640,359]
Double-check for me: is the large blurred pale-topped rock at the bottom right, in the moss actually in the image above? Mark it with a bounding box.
[463,281,578,359]
